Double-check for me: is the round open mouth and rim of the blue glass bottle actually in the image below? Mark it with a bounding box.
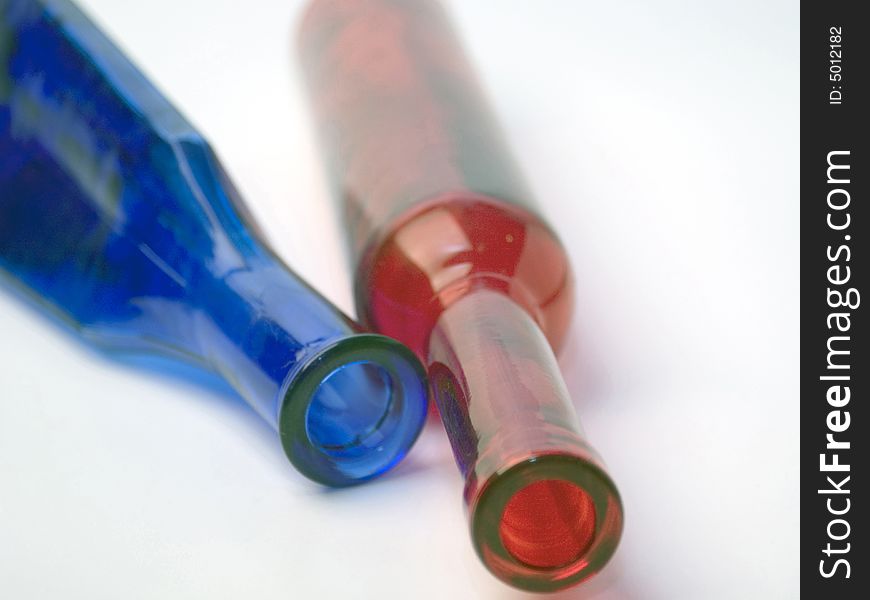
[278,334,428,487]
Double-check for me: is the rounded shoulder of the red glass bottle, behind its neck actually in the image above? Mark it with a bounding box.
[357,194,572,354]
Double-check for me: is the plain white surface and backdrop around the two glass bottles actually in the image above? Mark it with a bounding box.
[0,0,799,600]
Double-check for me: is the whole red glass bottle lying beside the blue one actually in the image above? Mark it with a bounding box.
[300,0,622,591]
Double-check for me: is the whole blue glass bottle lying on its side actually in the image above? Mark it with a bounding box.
[0,0,427,486]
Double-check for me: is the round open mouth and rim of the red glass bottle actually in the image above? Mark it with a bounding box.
[470,454,622,592]
